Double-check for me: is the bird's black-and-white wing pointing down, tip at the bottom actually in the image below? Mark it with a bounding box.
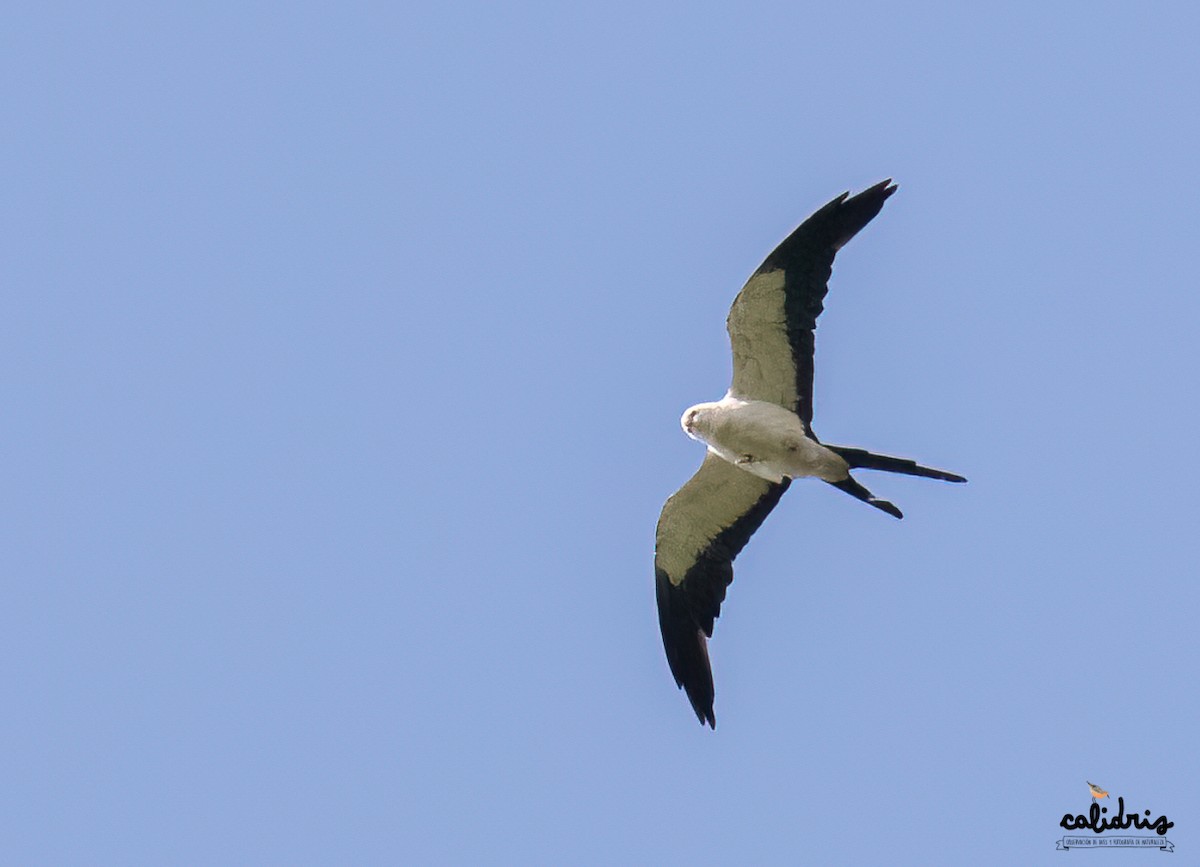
[654,453,788,728]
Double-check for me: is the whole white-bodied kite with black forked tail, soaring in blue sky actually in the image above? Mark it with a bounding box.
[654,180,966,729]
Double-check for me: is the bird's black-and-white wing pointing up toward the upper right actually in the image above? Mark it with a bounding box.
[725,180,895,432]
